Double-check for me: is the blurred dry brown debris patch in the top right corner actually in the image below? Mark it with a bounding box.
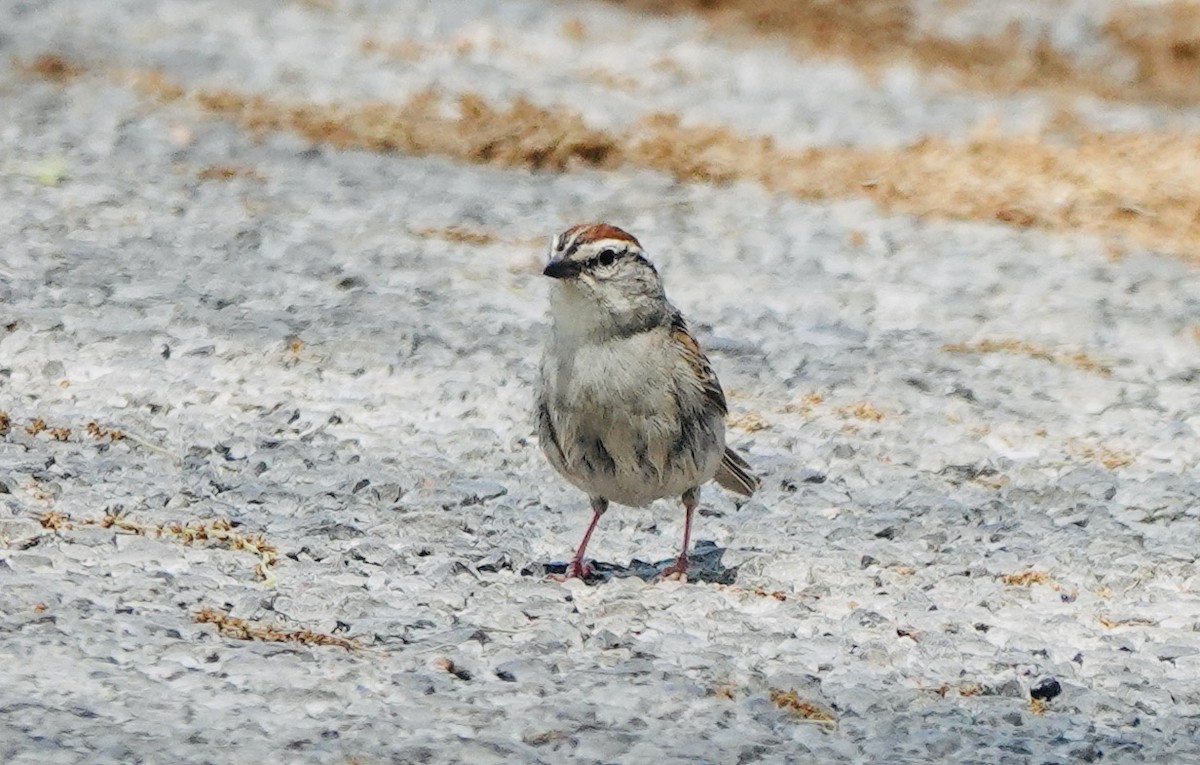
[611,0,1200,103]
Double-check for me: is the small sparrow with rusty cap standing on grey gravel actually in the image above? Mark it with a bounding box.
[538,223,758,578]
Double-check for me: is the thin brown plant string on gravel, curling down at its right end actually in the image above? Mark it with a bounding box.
[38,510,280,582]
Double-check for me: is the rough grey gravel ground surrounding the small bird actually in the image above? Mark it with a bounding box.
[0,0,1200,765]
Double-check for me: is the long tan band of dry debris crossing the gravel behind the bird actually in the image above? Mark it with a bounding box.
[182,83,1200,258]
